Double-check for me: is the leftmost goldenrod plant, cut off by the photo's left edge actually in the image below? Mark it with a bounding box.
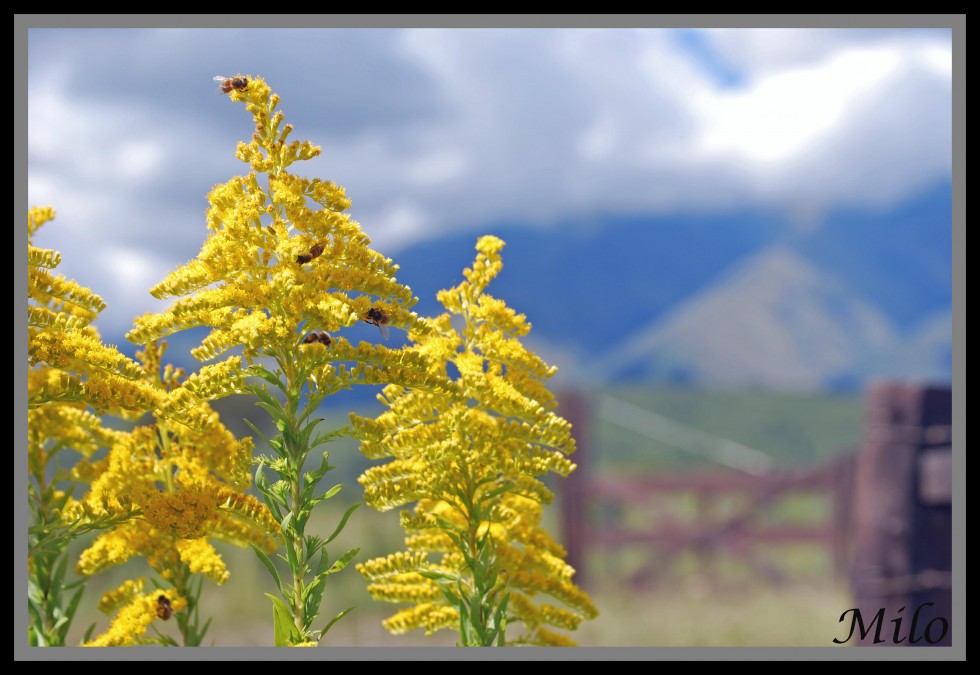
[27,207,162,645]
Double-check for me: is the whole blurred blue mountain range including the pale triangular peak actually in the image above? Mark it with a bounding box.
[395,184,952,390]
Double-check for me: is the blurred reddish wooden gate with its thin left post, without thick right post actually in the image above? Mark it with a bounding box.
[560,392,854,586]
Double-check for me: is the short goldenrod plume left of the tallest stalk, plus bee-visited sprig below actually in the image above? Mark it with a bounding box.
[70,342,279,645]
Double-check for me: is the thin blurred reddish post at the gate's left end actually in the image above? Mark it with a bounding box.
[558,389,591,587]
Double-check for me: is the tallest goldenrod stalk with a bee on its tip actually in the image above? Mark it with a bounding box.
[128,75,451,646]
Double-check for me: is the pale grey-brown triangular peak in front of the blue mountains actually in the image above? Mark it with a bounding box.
[591,244,897,389]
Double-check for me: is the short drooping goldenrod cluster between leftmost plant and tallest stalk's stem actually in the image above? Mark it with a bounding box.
[66,343,279,584]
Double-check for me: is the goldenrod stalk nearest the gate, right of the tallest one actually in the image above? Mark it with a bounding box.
[351,236,597,646]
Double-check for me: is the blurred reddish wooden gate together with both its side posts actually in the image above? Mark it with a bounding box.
[560,384,952,632]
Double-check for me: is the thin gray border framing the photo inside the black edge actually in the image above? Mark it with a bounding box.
[13,14,966,661]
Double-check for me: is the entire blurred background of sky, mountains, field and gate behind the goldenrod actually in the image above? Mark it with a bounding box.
[27,22,952,646]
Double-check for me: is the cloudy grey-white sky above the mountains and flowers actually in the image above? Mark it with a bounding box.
[27,20,952,344]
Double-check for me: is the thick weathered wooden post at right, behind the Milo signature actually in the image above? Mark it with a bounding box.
[841,383,952,646]
